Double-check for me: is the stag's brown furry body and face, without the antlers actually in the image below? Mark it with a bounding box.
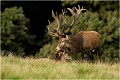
[56,31,101,60]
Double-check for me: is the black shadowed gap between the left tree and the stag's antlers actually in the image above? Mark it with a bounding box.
[1,1,62,55]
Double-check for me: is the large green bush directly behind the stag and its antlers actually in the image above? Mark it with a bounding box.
[37,1,119,62]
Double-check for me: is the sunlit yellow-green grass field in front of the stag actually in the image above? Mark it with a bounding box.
[0,56,119,80]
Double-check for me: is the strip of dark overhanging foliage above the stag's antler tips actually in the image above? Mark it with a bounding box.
[62,0,119,12]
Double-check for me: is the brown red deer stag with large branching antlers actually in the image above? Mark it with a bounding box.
[48,5,101,60]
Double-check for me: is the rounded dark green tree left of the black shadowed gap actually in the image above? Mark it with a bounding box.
[1,7,35,55]
